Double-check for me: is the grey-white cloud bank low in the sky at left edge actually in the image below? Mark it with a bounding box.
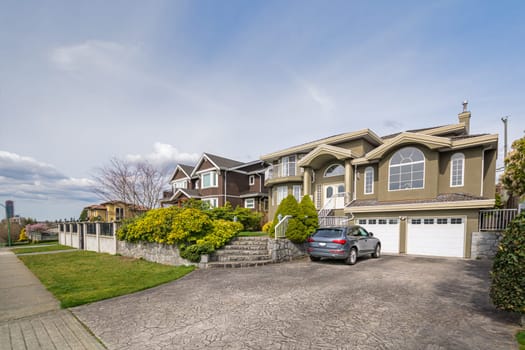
[0,151,95,202]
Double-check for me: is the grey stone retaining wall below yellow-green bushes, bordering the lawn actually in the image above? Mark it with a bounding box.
[117,241,197,265]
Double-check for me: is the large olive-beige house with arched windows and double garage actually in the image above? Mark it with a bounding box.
[261,102,498,258]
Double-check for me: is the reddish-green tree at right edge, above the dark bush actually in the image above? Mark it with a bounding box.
[501,137,525,196]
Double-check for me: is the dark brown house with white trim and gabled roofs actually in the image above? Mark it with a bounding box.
[161,153,268,219]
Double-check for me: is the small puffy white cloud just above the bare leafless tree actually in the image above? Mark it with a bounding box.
[126,142,199,168]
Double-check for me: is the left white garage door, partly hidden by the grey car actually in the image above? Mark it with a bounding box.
[357,218,399,253]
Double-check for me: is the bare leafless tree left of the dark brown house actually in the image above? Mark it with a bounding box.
[95,158,166,209]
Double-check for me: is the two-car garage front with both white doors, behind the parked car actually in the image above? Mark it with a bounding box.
[356,216,466,257]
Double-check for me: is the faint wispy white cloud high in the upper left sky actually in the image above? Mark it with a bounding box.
[49,40,137,71]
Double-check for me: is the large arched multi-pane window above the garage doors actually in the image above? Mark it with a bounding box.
[388,147,425,191]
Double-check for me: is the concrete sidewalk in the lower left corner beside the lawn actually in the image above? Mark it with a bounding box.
[0,248,105,350]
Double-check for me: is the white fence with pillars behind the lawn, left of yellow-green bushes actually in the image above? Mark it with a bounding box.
[58,222,119,254]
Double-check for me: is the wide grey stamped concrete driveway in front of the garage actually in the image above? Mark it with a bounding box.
[73,256,517,350]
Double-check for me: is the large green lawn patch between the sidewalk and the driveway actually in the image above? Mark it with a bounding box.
[18,251,195,308]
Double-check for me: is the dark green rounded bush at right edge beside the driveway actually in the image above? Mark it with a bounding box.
[490,213,525,314]
